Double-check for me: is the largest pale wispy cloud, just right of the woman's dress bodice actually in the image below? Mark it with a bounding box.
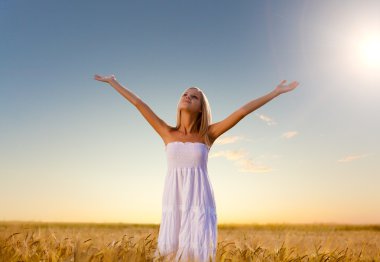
[210,149,272,173]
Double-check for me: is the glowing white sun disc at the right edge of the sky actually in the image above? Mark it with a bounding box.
[358,35,380,68]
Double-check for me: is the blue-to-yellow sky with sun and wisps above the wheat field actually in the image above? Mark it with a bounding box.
[0,0,380,224]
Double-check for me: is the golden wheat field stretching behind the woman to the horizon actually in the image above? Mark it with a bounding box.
[0,222,380,262]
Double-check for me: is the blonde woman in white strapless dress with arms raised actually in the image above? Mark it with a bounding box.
[95,72,298,261]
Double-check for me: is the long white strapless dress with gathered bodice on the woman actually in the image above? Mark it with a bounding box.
[155,141,217,261]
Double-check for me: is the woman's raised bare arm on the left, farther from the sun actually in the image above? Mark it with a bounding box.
[94,75,170,137]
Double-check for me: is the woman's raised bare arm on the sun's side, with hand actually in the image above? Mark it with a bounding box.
[209,80,299,141]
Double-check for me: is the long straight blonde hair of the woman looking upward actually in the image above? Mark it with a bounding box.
[175,86,212,148]
